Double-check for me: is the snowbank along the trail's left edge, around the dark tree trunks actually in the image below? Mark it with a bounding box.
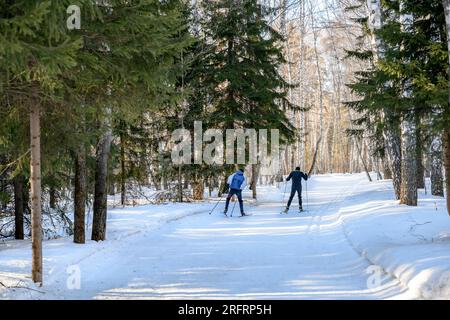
[0,203,211,299]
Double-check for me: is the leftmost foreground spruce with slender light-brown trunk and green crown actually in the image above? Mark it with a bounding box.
[0,1,85,283]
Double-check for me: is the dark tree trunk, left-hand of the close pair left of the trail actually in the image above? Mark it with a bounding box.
[73,144,86,243]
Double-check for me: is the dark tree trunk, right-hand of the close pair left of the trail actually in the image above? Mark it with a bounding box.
[92,115,112,241]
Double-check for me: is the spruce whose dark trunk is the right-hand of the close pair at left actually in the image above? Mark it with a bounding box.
[69,0,193,241]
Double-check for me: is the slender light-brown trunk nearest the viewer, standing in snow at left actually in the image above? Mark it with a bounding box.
[30,99,42,284]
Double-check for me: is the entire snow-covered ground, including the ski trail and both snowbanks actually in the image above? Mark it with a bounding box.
[0,174,450,299]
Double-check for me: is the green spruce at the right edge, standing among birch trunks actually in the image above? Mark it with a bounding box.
[348,0,448,209]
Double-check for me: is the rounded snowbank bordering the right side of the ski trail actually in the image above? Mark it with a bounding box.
[338,180,450,299]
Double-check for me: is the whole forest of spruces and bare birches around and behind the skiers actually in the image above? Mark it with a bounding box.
[0,0,450,298]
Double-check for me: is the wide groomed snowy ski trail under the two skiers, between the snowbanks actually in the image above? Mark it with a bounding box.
[3,176,418,299]
